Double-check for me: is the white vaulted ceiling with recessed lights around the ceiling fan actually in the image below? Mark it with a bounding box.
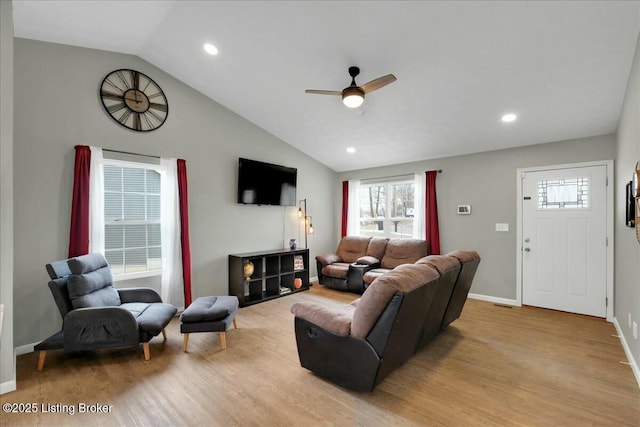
[13,0,640,171]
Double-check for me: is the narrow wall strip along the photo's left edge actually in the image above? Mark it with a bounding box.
[0,1,16,393]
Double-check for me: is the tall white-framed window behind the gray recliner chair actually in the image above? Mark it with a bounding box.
[104,159,162,275]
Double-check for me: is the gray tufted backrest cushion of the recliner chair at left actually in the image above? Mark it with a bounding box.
[67,253,121,308]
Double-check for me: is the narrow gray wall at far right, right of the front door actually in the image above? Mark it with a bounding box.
[614,31,640,374]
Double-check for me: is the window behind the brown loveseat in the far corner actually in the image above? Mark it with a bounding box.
[359,179,416,239]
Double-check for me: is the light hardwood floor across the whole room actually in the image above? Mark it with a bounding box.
[0,285,640,426]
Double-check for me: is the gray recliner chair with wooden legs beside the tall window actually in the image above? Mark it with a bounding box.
[34,253,178,371]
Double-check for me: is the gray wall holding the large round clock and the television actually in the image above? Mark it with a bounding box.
[12,38,337,346]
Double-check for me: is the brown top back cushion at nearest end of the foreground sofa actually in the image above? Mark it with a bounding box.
[351,264,438,339]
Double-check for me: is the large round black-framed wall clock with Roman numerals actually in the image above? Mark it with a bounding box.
[100,69,169,132]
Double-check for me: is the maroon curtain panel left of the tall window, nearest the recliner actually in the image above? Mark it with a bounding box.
[69,145,91,258]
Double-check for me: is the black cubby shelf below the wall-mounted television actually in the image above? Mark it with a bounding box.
[229,249,310,307]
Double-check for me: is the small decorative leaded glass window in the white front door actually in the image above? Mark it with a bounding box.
[538,177,589,209]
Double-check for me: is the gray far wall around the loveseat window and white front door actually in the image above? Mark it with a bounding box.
[336,135,615,300]
